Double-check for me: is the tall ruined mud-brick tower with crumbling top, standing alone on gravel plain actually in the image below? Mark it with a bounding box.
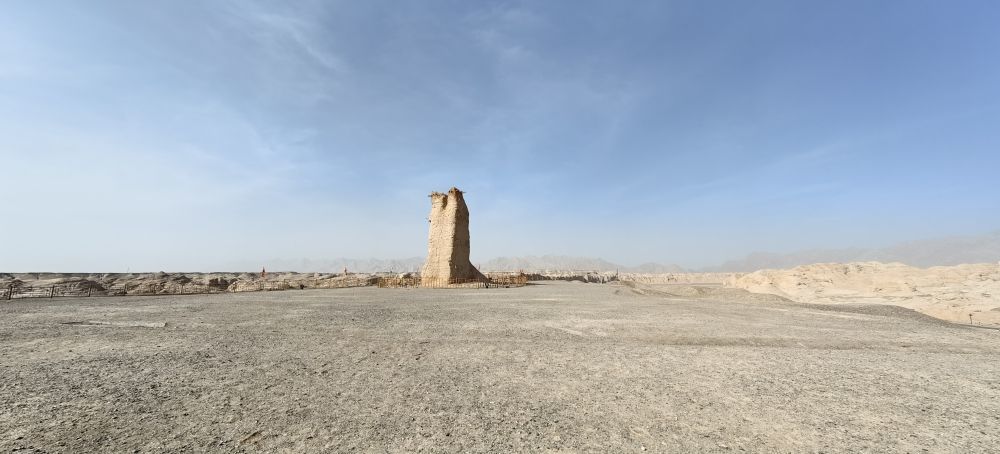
[420,188,488,287]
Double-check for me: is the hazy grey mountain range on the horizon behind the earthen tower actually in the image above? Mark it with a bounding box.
[252,230,1000,273]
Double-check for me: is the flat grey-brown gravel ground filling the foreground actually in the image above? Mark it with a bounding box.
[0,282,1000,452]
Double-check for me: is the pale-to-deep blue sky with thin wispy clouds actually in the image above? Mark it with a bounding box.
[0,0,1000,271]
